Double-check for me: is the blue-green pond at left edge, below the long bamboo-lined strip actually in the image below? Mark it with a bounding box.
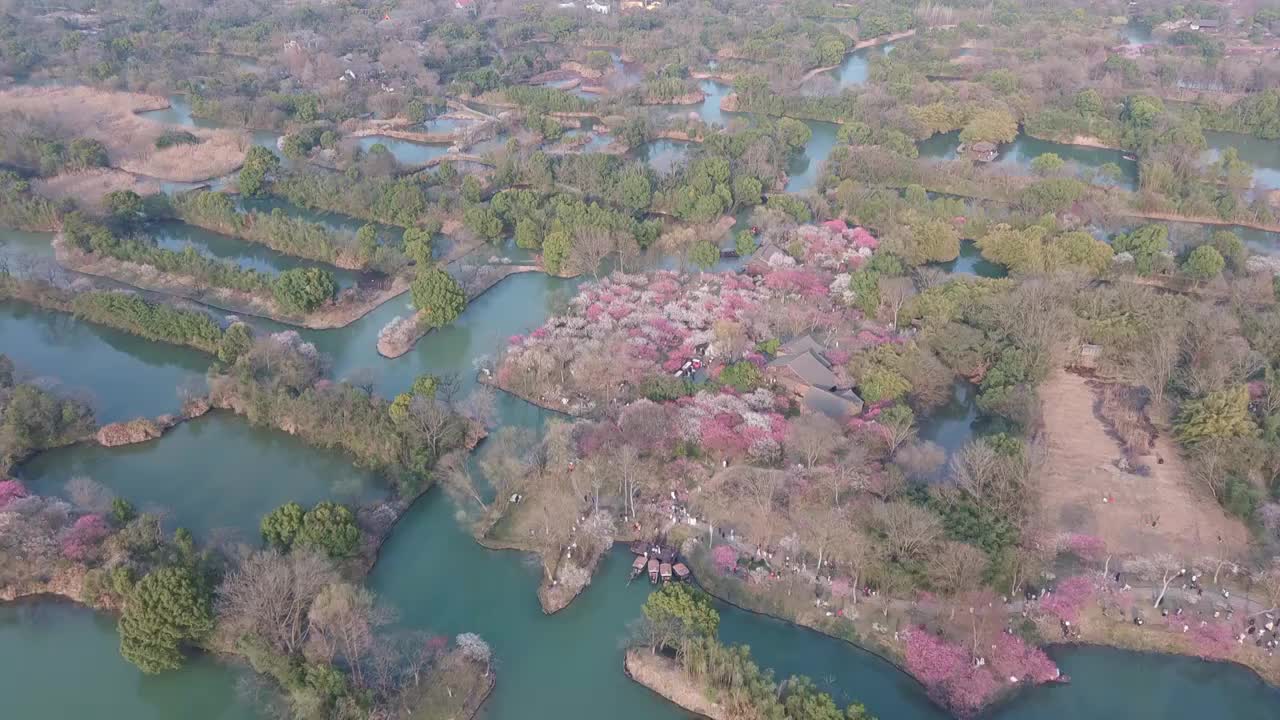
[0,297,211,423]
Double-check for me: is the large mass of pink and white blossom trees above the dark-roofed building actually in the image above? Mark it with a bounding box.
[497,223,877,404]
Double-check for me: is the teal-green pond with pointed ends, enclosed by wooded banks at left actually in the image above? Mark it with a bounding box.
[18,411,385,543]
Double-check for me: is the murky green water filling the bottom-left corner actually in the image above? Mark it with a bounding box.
[0,600,259,720]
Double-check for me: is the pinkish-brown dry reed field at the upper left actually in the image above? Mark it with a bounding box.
[0,87,250,182]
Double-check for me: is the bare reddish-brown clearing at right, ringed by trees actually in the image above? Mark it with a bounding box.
[1041,372,1248,560]
